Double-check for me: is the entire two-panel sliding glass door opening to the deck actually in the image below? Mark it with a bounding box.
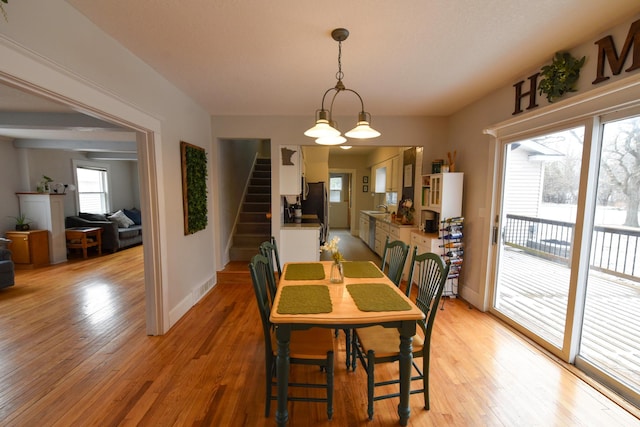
[491,111,640,405]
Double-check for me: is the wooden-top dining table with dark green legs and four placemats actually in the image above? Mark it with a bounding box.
[270,261,424,426]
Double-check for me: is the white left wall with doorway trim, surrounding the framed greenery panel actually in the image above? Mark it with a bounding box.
[0,0,217,332]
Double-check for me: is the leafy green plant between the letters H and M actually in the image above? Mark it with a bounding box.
[538,52,586,102]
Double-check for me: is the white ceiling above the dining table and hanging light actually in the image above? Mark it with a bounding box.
[0,0,640,151]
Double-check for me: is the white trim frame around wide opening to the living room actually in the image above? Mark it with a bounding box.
[0,38,170,335]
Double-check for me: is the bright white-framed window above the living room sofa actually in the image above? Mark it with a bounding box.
[75,164,109,213]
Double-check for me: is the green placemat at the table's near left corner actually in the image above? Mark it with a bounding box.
[278,285,333,314]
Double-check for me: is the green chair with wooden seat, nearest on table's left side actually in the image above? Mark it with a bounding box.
[249,255,334,419]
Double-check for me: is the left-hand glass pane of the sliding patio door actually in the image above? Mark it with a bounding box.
[494,127,584,348]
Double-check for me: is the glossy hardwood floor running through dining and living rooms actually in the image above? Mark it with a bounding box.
[0,247,640,426]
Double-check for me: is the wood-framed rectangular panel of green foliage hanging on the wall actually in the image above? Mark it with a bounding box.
[180,141,208,235]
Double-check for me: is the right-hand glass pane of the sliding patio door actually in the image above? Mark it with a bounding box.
[578,116,640,402]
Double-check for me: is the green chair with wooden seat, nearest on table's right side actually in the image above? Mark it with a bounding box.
[352,247,449,420]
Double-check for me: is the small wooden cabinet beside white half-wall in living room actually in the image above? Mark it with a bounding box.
[5,230,49,268]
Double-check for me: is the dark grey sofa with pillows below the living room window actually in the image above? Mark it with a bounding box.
[65,209,142,252]
